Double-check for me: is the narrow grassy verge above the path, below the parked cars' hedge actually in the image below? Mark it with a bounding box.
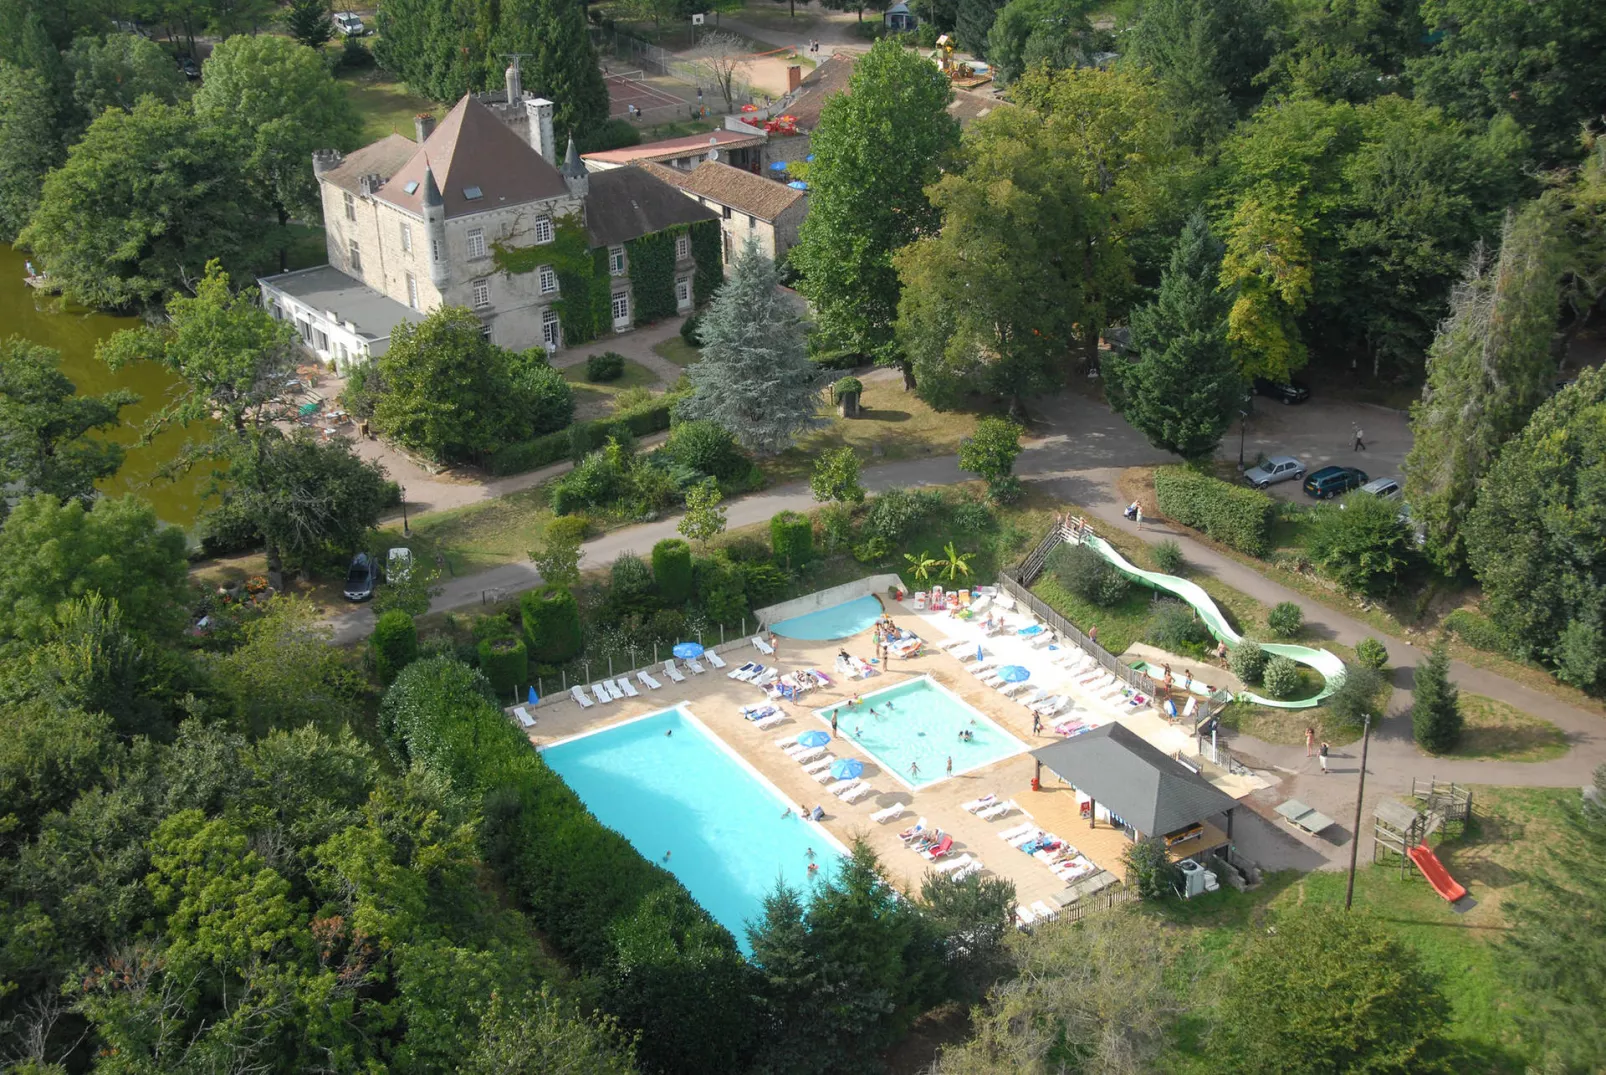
[1118,466,1606,715]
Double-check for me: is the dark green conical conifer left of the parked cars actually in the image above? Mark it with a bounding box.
[1105,212,1246,460]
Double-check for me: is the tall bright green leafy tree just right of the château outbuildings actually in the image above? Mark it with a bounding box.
[790,40,959,377]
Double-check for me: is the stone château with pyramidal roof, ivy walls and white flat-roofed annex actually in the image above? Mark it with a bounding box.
[257,59,723,368]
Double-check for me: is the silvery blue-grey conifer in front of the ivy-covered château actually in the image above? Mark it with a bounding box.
[681,238,825,455]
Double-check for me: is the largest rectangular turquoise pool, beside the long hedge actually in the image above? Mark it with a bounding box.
[541,709,840,953]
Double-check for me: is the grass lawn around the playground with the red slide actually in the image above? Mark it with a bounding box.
[1143,787,1577,1075]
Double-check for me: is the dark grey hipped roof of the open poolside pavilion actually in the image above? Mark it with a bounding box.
[1031,723,1238,836]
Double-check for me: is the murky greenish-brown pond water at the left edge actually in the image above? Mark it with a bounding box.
[0,244,212,530]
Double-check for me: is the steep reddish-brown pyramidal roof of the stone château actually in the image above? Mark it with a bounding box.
[375,96,569,220]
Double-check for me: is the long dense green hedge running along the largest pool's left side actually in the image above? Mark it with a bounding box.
[381,657,760,1072]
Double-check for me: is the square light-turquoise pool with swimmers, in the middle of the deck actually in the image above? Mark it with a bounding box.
[814,678,1026,787]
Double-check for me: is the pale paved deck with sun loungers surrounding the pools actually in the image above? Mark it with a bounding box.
[530,596,1248,905]
